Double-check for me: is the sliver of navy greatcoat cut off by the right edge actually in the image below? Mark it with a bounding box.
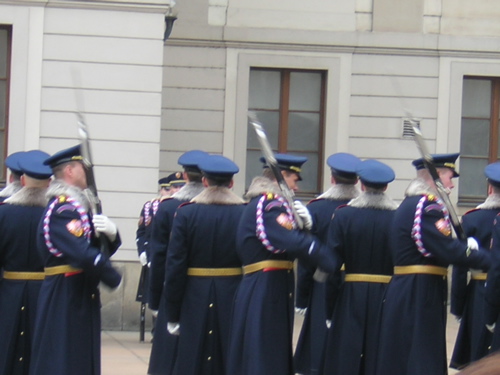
[484,214,500,352]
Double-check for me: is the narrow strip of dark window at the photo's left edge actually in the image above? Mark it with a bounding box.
[0,25,12,183]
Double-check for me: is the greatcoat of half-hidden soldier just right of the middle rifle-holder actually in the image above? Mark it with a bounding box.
[293,189,358,375]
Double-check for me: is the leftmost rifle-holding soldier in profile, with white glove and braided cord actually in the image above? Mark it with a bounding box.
[30,145,121,375]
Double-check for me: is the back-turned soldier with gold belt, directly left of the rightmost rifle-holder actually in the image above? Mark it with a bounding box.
[323,160,397,375]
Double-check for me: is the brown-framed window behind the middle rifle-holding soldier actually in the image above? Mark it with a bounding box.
[246,68,326,197]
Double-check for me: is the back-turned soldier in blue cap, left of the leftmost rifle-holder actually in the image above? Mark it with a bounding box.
[0,150,52,375]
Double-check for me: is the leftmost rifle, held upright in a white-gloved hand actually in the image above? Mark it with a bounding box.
[73,73,111,258]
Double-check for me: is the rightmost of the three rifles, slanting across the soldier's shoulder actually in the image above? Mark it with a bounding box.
[409,123,467,241]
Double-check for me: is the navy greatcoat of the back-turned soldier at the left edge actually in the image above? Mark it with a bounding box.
[0,189,45,375]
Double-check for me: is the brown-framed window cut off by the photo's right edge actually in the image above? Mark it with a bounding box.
[458,77,500,206]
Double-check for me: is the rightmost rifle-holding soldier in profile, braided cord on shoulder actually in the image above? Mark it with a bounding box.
[376,154,490,375]
